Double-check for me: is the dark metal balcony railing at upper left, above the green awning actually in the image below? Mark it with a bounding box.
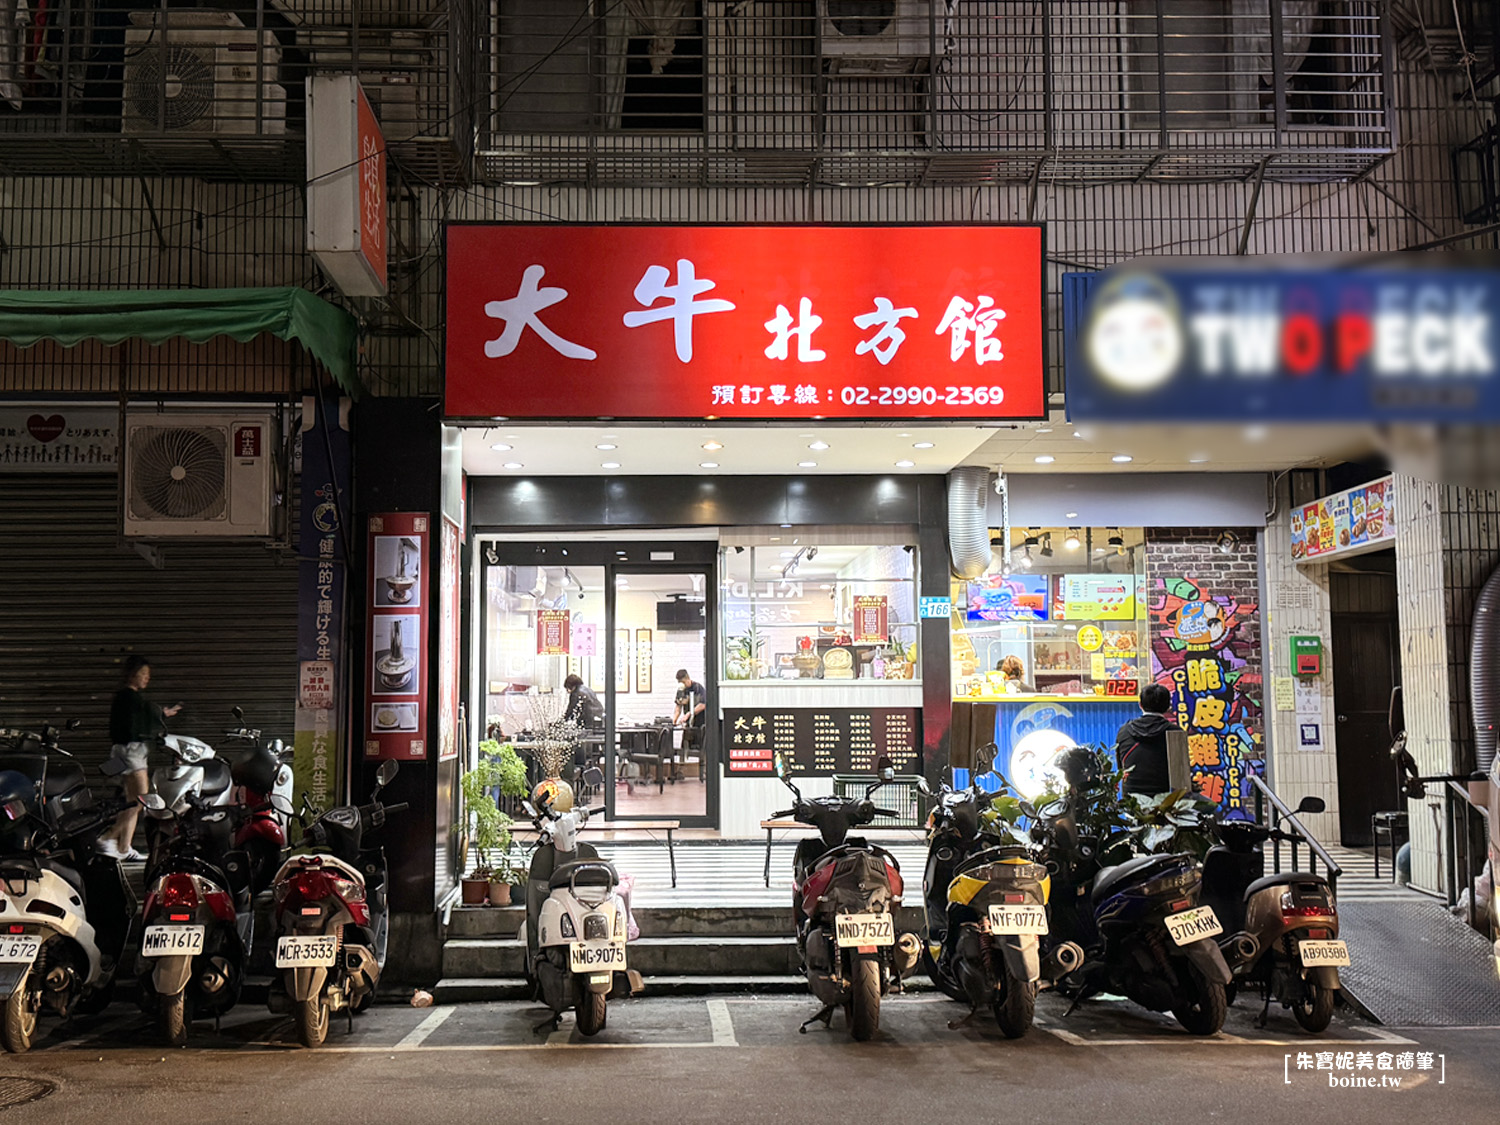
[0,0,488,180]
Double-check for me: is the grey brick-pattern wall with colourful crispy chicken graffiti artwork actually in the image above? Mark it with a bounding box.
[1146,528,1265,816]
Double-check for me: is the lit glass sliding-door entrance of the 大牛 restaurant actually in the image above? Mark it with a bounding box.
[477,537,720,827]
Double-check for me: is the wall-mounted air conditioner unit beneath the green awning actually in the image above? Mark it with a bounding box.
[120,411,281,539]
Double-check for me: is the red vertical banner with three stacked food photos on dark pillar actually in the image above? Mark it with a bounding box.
[365,512,432,761]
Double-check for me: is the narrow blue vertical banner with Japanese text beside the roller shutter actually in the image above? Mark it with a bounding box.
[293,396,351,809]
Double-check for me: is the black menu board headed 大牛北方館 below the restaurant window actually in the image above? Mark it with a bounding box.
[725,707,923,776]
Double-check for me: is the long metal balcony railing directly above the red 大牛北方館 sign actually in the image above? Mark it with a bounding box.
[479,0,1395,185]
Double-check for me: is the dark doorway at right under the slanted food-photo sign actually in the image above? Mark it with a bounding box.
[1329,567,1404,848]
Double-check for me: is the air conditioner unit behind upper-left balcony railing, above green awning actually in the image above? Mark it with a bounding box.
[120,9,287,137]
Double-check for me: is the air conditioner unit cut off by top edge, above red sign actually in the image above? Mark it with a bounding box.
[818,0,948,74]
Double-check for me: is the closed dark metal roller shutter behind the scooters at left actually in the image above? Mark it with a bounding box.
[0,474,297,774]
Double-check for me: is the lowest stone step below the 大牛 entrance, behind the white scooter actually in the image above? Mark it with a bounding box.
[443,933,798,978]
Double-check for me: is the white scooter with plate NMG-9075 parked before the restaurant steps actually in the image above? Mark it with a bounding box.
[525,767,630,1035]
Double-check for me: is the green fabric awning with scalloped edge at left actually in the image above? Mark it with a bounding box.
[0,288,360,398]
